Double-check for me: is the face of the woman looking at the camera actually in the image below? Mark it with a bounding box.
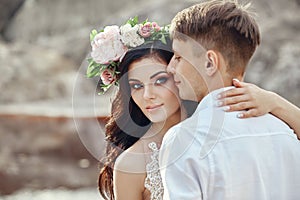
[128,58,180,123]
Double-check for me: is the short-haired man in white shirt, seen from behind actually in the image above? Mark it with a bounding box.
[160,0,300,200]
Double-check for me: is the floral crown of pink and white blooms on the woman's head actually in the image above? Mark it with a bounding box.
[86,17,169,93]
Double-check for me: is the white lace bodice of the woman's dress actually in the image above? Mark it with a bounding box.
[145,142,164,200]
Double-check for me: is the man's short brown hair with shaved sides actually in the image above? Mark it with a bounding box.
[170,0,260,73]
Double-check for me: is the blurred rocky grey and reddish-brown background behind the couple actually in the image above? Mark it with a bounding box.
[0,0,300,200]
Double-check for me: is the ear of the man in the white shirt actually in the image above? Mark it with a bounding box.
[205,50,219,76]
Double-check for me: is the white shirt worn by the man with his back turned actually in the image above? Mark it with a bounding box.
[160,88,300,200]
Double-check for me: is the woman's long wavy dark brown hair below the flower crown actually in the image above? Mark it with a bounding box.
[98,39,173,200]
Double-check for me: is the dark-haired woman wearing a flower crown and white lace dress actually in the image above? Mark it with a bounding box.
[87,18,300,200]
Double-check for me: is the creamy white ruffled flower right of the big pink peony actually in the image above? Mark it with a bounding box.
[120,24,145,47]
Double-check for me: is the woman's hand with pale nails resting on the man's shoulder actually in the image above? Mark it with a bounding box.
[218,79,276,118]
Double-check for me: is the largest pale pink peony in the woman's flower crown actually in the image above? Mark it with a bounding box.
[91,26,127,64]
